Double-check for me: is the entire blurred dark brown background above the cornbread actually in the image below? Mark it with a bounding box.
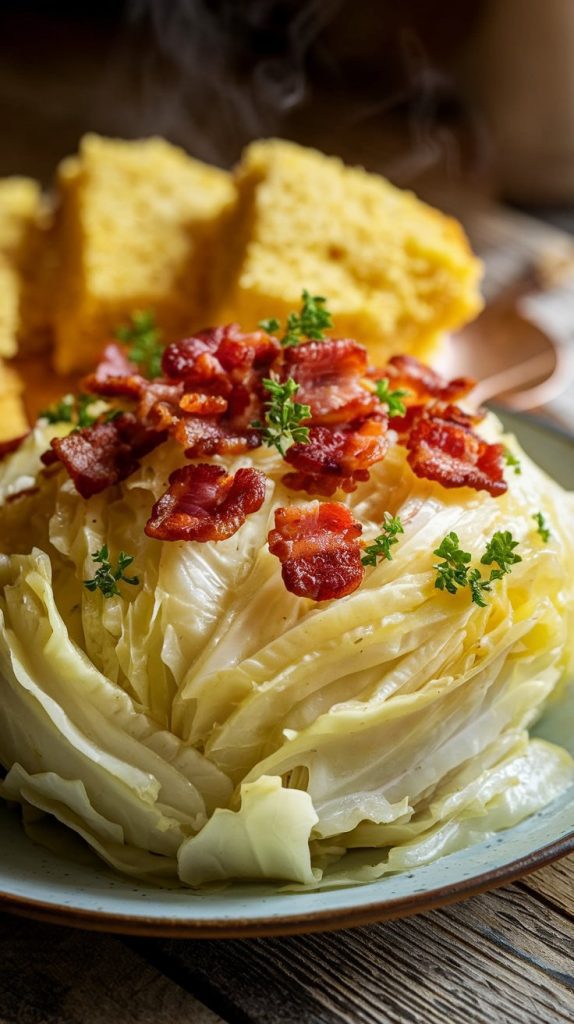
[0,0,574,212]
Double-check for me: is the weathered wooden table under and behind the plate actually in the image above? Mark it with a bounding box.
[0,203,574,1024]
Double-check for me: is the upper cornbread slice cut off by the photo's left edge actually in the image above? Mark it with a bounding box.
[0,177,51,356]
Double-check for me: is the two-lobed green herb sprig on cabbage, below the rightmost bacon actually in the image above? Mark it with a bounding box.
[433,529,522,608]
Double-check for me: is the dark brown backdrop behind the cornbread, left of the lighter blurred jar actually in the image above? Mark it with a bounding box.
[0,0,485,183]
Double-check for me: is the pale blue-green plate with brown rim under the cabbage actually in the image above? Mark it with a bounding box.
[0,414,574,938]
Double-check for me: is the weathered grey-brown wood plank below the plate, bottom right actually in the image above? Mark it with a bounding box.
[126,886,574,1024]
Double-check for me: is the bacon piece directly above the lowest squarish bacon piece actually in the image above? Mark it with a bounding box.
[283,418,389,497]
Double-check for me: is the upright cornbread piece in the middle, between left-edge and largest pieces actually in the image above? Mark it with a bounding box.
[54,135,235,373]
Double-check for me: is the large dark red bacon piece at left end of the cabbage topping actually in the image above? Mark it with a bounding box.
[42,413,167,498]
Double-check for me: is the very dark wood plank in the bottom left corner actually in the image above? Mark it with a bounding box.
[0,914,222,1024]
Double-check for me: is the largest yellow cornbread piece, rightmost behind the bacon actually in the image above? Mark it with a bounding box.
[218,139,482,358]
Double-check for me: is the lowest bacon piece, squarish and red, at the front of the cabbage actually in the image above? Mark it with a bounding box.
[268,502,363,601]
